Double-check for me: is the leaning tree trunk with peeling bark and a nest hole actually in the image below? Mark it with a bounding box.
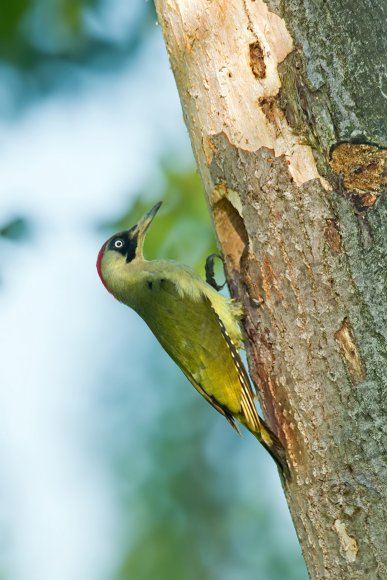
[156,0,387,580]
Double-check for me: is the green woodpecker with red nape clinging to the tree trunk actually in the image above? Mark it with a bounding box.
[97,202,288,474]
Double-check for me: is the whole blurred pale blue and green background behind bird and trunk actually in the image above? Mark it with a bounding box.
[0,0,306,580]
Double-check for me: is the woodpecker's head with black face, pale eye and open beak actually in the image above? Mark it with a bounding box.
[97,201,161,292]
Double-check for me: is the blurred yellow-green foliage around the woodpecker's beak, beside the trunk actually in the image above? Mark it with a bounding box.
[103,164,220,274]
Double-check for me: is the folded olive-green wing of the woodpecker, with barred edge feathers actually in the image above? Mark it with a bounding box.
[140,279,259,429]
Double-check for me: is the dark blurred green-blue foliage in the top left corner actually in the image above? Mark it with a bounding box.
[0,0,156,81]
